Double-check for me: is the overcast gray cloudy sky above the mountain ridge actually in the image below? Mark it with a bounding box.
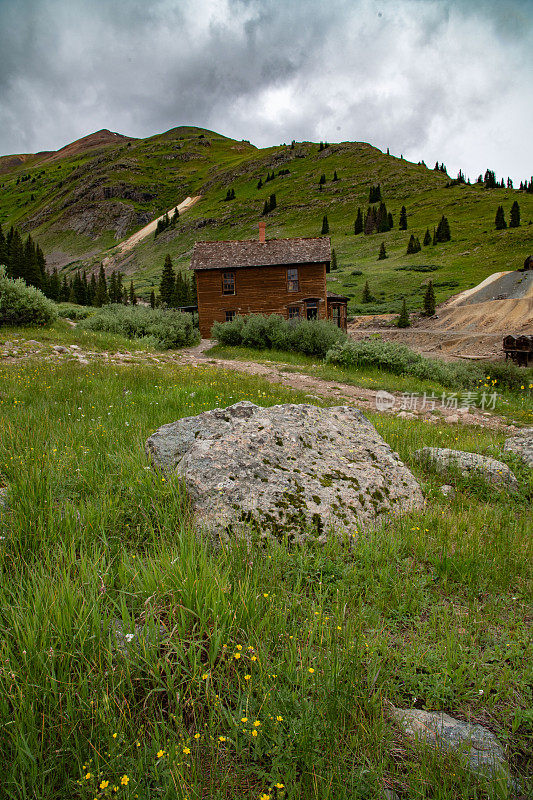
[0,0,533,181]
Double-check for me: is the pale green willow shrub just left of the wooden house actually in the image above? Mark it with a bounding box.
[80,305,200,350]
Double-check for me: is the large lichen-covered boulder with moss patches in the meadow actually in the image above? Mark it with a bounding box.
[146,401,424,540]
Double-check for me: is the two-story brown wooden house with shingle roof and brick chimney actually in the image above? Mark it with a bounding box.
[191,222,348,338]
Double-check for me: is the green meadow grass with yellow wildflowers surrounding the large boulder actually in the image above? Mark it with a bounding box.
[0,340,533,800]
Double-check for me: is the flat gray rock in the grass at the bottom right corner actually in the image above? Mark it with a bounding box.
[391,708,508,776]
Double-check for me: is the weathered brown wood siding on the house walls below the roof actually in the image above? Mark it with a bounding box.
[196,263,327,339]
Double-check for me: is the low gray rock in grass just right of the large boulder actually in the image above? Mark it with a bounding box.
[415,447,518,491]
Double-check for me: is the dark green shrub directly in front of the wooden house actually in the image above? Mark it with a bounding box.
[211,314,347,358]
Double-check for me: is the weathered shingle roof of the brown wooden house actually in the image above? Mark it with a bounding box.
[191,236,331,270]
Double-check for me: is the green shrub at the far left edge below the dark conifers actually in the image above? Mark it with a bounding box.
[0,265,57,325]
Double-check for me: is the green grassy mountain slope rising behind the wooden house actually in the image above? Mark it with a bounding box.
[0,127,533,312]
